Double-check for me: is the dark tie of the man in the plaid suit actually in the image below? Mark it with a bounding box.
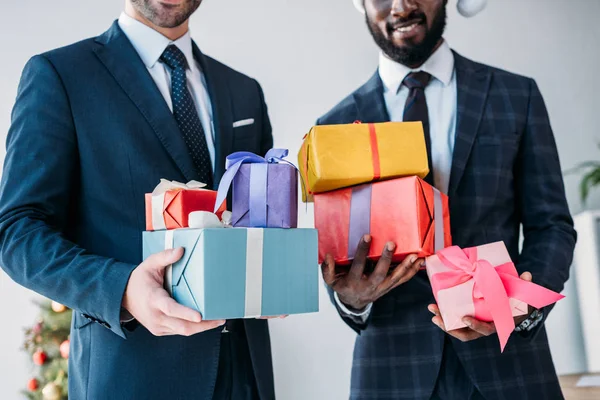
[402,71,433,186]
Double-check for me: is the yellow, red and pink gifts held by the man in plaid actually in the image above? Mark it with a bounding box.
[298,122,562,350]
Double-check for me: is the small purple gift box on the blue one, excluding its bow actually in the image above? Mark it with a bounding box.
[231,164,298,228]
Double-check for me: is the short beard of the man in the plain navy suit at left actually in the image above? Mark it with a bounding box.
[131,0,202,28]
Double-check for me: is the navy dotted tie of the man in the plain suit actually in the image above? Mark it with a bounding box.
[160,44,213,188]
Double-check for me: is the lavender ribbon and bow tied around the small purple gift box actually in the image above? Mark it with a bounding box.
[215,149,297,227]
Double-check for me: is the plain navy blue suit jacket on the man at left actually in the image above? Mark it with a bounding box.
[0,22,274,399]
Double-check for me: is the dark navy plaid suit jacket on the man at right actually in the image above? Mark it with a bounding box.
[318,53,576,400]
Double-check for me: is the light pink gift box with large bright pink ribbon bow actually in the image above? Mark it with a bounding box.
[426,242,564,351]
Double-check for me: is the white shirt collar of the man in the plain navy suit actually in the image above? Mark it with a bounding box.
[119,12,194,68]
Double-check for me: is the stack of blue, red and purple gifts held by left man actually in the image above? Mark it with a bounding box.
[143,149,318,320]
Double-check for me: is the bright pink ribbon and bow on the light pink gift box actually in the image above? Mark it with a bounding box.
[430,246,564,351]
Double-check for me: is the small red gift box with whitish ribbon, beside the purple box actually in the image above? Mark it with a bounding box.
[145,181,226,231]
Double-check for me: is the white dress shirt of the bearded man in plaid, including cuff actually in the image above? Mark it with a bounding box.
[334,41,458,322]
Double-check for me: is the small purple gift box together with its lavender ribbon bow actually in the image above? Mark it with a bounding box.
[215,149,298,228]
